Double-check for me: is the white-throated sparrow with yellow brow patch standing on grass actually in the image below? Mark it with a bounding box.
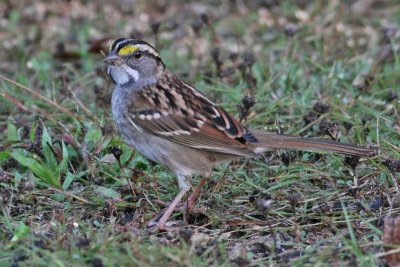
[103,38,376,230]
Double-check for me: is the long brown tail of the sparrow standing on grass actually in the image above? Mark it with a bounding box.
[251,130,377,157]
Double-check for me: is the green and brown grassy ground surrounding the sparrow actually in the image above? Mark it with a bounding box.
[0,1,400,266]
